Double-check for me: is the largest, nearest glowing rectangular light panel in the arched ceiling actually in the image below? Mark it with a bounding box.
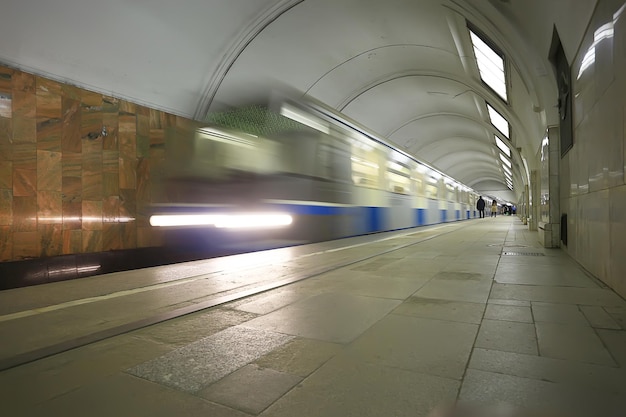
[470,29,508,101]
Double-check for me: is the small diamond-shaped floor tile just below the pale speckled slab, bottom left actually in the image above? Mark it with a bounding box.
[197,365,302,414]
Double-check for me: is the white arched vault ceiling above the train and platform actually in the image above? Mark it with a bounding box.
[0,0,595,201]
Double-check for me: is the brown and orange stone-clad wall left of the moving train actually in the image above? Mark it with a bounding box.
[0,65,194,262]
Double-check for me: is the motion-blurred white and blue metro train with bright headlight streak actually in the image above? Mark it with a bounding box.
[150,98,478,250]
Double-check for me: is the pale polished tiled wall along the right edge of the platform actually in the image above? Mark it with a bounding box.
[560,0,626,296]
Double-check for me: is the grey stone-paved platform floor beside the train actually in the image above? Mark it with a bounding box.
[0,217,626,417]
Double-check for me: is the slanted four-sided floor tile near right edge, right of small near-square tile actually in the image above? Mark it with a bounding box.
[535,323,616,366]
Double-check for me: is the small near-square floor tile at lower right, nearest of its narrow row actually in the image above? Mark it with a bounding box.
[475,319,537,355]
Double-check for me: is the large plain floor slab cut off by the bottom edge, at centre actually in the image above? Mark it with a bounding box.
[260,355,460,417]
